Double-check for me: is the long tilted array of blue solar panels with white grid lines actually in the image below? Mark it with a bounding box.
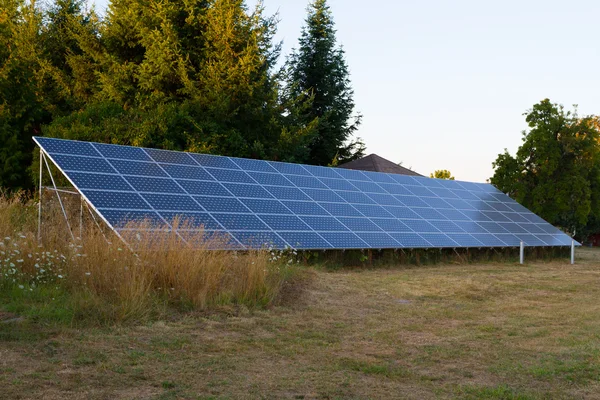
[34,137,571,250]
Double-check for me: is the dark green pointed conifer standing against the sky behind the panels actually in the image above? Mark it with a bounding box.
[287,0,365,165]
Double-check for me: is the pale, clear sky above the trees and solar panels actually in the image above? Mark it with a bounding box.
[91,0,600,182]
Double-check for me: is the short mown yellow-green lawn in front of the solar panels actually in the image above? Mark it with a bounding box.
[0,245,600,400]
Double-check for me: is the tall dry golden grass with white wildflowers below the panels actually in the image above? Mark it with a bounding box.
[0,192,294,322]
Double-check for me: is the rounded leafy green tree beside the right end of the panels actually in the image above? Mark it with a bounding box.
[490,99,600,238]
